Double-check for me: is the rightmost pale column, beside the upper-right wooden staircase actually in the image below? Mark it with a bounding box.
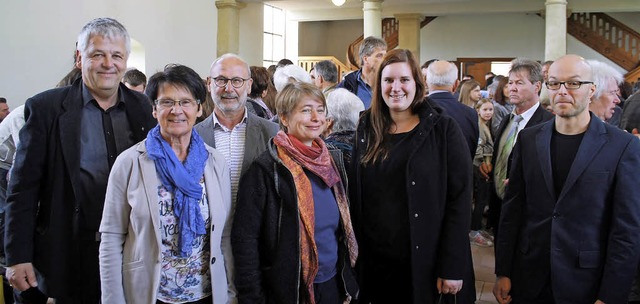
[544,0,567,61]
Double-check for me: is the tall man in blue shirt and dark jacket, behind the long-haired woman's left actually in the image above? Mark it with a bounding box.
[337,36,387,109]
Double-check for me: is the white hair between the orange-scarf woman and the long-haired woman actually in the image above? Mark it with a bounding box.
[327,88,364,132]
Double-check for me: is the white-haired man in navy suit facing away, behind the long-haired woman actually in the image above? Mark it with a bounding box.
[427,60,480,159]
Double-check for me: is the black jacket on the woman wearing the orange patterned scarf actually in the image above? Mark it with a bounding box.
[231,140,358,304]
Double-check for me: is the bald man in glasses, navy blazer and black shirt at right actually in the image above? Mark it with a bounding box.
[493,55,640,304]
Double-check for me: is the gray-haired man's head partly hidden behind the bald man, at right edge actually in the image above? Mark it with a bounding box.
[587,60,623,127]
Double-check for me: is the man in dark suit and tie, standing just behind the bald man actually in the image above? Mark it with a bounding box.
[488,58,553,237]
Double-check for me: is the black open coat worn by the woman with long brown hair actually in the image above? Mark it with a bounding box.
[350,102,476,303]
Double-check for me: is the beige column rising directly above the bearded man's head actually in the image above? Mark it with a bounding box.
[216,0,246,56]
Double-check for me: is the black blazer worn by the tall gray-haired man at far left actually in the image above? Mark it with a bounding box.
[5,79,156,297]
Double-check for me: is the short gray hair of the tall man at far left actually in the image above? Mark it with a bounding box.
[76,18,131,55]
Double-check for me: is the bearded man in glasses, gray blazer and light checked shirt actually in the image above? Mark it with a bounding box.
[195,54,279,204]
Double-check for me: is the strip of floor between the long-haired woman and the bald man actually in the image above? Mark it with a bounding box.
[471,245,498,304]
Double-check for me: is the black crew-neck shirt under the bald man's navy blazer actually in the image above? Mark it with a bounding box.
[551,129,584,198]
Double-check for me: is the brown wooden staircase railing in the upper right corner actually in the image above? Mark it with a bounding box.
[567,13,640,82]
